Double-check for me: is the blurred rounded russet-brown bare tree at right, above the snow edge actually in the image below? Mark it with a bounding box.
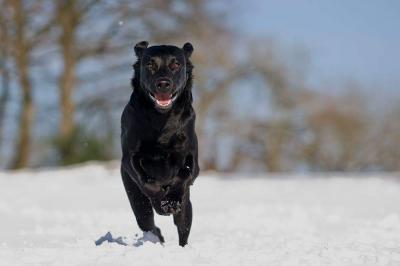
[304,96,365,171]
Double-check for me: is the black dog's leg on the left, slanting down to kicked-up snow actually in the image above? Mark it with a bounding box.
[121,169,164,243]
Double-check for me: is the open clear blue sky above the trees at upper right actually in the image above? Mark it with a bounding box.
[230,0,400,95]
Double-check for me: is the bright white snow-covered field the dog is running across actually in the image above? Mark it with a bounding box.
[0,164,400,266]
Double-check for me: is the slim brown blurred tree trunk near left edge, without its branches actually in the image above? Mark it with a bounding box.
[9,0,34,169]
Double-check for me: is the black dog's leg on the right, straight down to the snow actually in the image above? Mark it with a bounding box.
[174,188,192,247]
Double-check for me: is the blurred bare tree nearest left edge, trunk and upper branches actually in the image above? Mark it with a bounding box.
[2,0,52,168]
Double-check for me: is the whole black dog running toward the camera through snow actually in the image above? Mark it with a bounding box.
[121,42,199,246]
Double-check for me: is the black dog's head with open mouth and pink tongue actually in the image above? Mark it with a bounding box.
[134,41,193,113]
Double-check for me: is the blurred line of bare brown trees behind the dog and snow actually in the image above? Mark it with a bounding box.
[0,0,400,171]
